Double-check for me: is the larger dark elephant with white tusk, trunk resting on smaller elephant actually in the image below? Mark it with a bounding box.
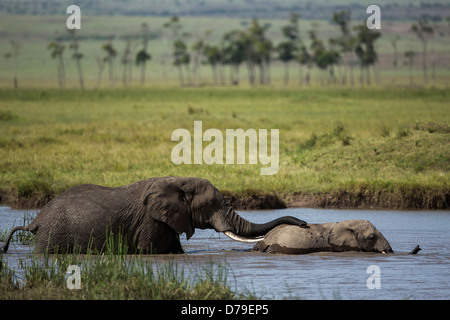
[0,177,307,254]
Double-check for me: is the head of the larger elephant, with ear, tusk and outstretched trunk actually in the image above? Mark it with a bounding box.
[145,177,306,242]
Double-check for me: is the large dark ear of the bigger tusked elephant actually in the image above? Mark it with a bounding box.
[144,177,194,240]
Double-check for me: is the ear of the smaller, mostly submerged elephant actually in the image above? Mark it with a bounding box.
[328,221,361,251]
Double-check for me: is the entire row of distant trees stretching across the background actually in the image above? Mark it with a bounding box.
[5,10,450,88]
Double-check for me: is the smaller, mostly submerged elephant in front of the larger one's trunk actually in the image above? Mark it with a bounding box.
[252,220,393,254]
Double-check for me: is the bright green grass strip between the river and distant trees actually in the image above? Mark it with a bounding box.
[0,86,450,208]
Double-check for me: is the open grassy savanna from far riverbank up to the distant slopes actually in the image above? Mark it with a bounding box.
[0,8,450,209]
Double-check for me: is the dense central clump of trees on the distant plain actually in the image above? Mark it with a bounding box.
[160,10,381,86]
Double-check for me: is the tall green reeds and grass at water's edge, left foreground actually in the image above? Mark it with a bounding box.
[0,232,250,300]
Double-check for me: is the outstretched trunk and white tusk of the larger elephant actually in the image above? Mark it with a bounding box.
[211,207,307,242]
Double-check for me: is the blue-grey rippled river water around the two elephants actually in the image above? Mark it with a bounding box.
[0,207,450,300]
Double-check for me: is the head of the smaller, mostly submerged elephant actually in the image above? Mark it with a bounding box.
[327,220,393,253]
